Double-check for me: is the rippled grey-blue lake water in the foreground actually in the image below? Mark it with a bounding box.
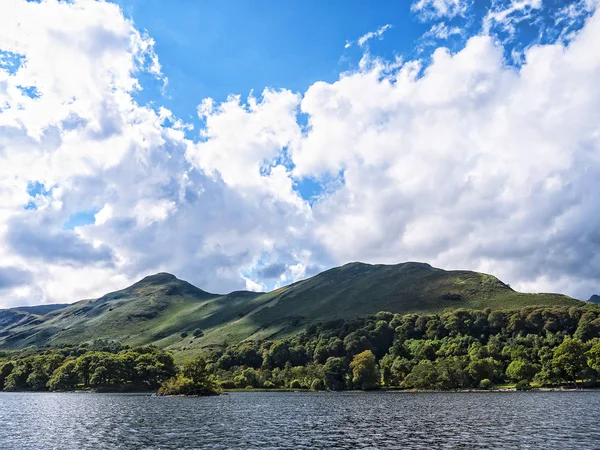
[0,392,600,450]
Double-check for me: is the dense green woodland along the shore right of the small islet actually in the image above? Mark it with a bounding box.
[207,305,600,390]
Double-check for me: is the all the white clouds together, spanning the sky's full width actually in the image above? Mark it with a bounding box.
[0,0,600,306]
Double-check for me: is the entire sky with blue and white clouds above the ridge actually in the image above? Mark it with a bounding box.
[0,0,600,307]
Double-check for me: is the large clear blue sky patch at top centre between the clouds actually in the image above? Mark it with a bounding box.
[117,0,428,118]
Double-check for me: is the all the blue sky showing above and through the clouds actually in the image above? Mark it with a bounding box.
[109,0,591,203]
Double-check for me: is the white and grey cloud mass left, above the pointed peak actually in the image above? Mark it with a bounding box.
[0,0,310,306]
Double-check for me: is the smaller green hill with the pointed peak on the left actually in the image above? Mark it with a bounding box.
[0,273,268,349]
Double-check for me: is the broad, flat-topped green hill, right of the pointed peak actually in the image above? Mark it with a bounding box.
[198,263,581,348]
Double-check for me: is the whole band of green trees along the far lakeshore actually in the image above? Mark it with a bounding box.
[0,305,600,395]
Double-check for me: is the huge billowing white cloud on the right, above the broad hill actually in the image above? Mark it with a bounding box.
[293,8,600,296]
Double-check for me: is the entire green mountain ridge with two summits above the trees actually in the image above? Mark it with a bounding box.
[0,262,582,354]
